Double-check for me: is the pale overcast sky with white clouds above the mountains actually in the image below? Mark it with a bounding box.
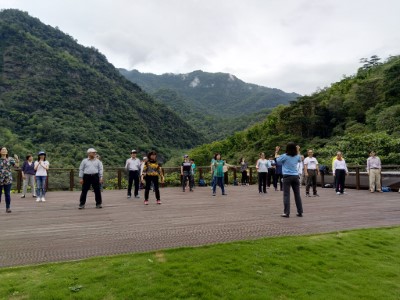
[0,0,400,95]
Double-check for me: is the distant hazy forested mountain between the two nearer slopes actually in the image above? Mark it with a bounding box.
[120,69,300,142]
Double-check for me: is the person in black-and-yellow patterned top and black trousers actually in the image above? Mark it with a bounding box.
[142,151,164,205]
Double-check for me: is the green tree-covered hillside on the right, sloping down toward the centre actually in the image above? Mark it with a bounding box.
[191,56,400,165]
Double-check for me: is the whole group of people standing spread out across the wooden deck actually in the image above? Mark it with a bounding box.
[0,143,394,214]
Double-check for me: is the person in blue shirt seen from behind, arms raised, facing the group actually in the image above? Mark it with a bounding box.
[275,142,303,218]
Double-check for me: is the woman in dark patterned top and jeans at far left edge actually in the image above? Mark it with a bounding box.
[0,147,19,213]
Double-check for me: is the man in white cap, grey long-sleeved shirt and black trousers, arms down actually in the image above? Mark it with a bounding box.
[79,148,103,209]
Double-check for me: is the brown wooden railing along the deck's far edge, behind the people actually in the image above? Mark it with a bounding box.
[10,165,400,192]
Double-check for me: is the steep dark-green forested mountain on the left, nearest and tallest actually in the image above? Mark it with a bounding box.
[0,9,203,166]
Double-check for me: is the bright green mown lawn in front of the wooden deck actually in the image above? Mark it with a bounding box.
[0,227,400,300]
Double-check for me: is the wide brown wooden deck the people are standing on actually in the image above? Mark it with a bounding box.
[0,186,400,267]
